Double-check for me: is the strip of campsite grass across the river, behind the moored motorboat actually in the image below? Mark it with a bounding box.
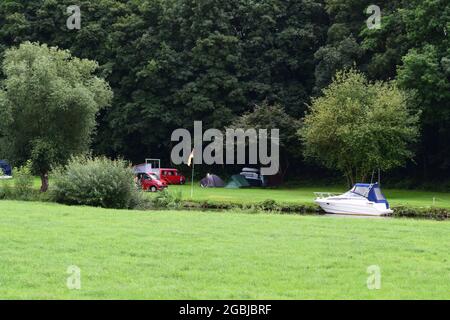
[170,185,450,208]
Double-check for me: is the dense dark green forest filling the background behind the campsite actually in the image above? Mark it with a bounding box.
[0,0,450,184]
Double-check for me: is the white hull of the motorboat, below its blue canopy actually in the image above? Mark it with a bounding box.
[315,198,393,216]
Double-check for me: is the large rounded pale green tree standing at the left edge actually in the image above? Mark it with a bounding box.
[0,42,112,192]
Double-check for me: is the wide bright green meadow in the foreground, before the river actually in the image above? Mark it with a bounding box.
[0,201,450,299]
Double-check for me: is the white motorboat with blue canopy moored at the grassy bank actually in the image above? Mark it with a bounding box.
[314,183,393,216]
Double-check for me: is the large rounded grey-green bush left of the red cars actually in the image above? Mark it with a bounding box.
[50,157,143,209]
